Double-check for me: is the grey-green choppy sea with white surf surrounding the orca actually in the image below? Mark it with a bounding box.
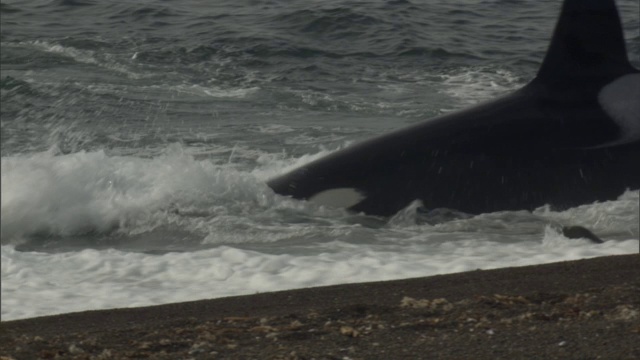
[0,0,640,321]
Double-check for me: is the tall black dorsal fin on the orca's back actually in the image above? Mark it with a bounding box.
[537,0,634,83]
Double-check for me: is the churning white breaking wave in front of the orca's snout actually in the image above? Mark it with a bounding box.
[1,146,271,244]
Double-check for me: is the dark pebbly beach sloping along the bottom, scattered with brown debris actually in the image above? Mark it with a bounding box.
[0,255,640,360]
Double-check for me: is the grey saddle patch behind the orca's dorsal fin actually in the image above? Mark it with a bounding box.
[598,74,640,144]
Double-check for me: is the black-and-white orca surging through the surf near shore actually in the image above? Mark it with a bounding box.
[267,0,640,216]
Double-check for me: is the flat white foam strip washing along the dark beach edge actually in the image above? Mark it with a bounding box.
[2,230,638,321]
